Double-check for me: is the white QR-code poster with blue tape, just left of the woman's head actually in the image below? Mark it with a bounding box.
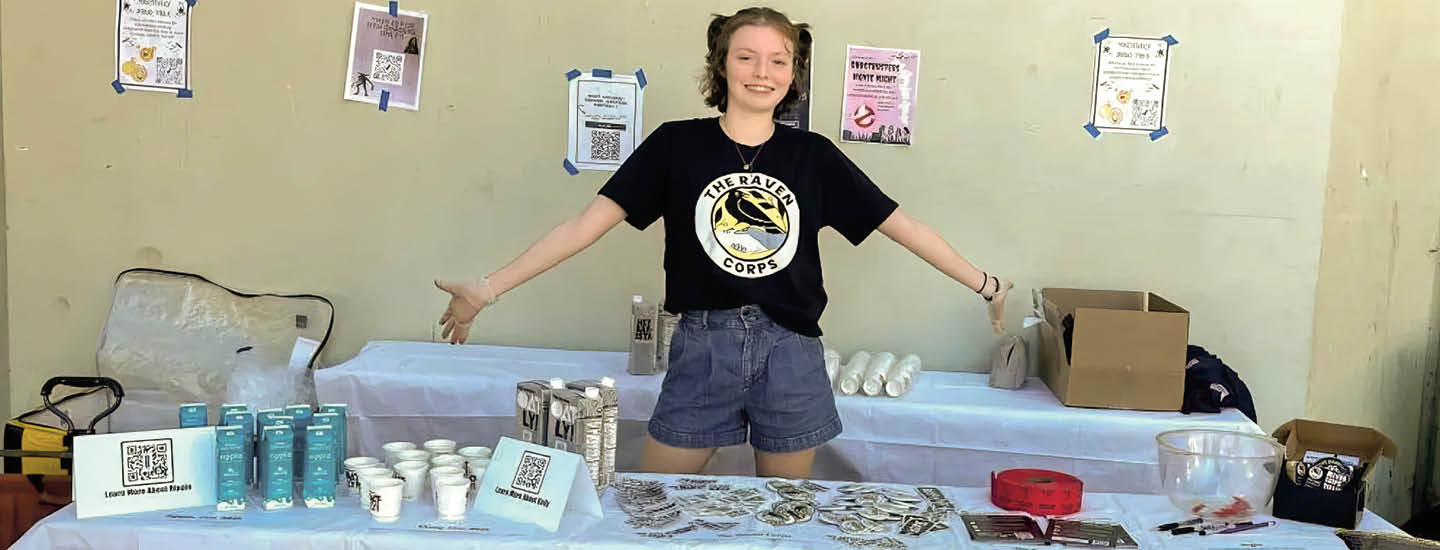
[564,69,645,170]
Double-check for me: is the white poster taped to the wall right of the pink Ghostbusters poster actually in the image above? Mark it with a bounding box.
[1090,33,1174,134]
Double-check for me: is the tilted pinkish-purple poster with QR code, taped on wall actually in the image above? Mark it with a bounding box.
[344,3,429,111]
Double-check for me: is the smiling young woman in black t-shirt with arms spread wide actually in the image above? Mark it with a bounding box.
[436,7,1011,478]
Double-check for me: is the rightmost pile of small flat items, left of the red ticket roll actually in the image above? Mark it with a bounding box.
[816,484,955,537]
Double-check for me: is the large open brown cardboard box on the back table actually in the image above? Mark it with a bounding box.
[1037,288,1189,410]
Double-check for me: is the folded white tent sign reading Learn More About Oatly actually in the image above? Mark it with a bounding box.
[475,438,605,531]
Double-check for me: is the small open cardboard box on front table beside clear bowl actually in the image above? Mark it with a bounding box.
[1273,419,1395,528]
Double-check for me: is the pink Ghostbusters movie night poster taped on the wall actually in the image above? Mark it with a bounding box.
[840,46,920,145]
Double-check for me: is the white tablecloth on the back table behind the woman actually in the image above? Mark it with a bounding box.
[315,341,1263,494]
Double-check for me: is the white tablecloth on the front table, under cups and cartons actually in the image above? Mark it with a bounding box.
[13,475,1397,550]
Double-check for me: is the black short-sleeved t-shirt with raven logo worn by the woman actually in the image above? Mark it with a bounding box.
[600,118,897,337]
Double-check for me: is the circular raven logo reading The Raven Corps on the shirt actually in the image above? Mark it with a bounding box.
[696,173,801,279]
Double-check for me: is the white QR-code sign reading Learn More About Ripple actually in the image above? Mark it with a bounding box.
[75,426,216,518]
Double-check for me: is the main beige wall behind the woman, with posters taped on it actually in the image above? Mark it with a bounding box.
[14,0,1416,512]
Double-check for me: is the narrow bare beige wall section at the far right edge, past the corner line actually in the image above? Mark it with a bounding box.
[1305,0,1440,518]
